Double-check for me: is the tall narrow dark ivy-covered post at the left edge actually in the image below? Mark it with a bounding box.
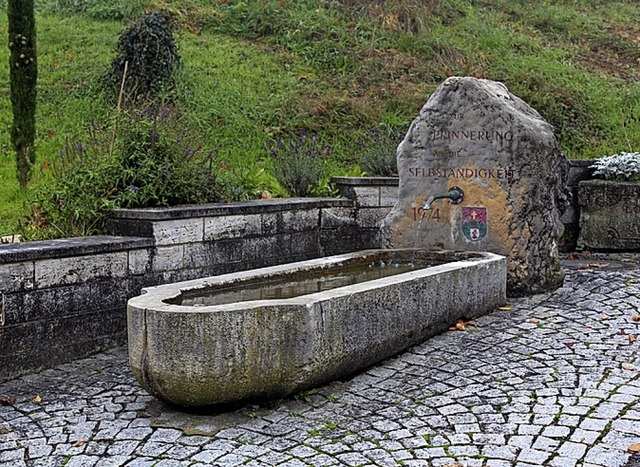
[7,0,38,189]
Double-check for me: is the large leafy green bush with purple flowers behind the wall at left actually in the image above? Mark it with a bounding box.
[23,108,224,239]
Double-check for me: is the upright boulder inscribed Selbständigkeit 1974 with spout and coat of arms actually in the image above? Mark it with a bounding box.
[381,77,570,296]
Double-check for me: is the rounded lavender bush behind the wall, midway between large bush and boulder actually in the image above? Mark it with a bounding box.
[269,130,331,196]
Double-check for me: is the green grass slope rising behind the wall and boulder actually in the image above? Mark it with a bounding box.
[0,0,640,234]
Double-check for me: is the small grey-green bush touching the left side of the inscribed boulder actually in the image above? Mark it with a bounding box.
[358,128,404,177]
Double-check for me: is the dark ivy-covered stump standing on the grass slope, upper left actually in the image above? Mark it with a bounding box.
[109,11,180,101]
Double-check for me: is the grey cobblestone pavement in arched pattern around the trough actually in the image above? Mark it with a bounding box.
[0,264,640,467]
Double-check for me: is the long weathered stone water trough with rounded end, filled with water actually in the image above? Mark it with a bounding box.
[128,249,507,407]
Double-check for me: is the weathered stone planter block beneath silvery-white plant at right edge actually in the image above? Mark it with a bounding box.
[578,180,640,251]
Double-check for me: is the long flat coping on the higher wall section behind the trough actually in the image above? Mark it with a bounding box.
[110,198,353,221]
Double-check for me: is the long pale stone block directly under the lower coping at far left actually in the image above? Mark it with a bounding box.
[35,251,129,288]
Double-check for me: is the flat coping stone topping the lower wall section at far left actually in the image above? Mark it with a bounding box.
[0,235,154,264]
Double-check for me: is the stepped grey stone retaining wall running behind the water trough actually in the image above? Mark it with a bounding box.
[0,198,378,381]
